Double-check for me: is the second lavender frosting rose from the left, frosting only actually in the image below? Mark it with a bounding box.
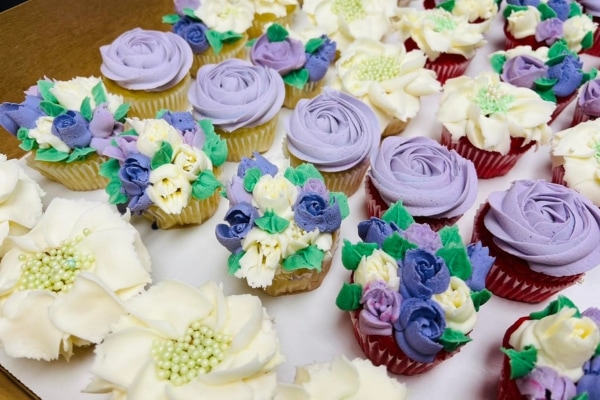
[188,59,285,132]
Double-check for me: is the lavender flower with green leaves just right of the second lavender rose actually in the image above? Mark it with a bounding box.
[250,34,306,76]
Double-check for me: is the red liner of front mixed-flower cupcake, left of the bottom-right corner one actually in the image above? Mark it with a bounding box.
[350,309,460,375]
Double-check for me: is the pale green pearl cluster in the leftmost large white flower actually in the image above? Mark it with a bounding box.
[17,229,95,293]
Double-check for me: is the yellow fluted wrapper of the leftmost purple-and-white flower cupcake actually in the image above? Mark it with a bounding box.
[26,151,108,192]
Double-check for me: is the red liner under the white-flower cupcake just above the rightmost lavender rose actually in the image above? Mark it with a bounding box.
[440,127,535,179]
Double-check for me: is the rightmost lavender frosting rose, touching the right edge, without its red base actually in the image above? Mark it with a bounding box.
[484,180,600,277]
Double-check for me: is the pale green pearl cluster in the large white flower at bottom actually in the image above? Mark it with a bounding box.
[151,321,231,386]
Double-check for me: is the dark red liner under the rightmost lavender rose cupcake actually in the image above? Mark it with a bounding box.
[471,203,584,303]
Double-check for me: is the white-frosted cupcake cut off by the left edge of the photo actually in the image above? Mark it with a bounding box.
[0,153,46,260]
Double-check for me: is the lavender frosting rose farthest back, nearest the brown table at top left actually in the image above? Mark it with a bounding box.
[100,28,193,91]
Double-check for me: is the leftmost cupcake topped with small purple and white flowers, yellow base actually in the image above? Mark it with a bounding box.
[0,77,129,191]
